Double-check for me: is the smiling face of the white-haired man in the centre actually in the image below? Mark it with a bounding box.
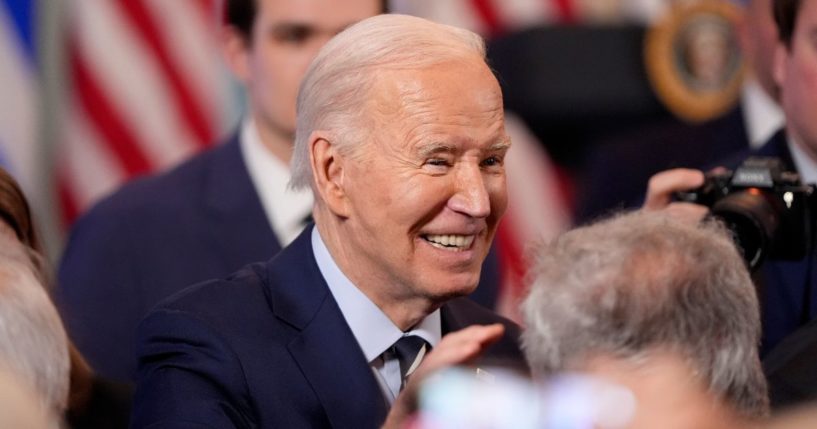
[334,58,510,305]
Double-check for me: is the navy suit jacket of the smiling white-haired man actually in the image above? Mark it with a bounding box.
[127,228,523,428]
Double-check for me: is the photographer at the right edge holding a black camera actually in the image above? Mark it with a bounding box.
[644,0,817,407]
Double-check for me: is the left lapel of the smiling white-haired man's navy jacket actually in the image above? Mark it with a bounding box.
[268,231,387,428]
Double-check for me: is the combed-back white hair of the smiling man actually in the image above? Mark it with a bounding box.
[290,14,485,188]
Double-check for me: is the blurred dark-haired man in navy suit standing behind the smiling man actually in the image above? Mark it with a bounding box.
[56,0,384,381]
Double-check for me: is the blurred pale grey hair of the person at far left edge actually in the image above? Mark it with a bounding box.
[0,240,71,415]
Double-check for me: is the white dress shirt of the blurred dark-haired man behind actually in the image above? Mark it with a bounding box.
[240,117,313,247]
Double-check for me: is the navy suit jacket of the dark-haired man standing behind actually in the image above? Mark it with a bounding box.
[56,135,499,380]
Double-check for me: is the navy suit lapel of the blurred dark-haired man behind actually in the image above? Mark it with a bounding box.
[204,135,281,270]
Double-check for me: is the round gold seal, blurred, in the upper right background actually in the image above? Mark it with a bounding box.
[644,0,744,122]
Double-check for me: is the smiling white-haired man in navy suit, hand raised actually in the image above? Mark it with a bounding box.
[132,15,523,428]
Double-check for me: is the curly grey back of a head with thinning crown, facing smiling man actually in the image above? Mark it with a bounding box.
[523,212,768,417]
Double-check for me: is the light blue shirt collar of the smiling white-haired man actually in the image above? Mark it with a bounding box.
[312,227,442,363]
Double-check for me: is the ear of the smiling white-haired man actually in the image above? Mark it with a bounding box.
[309,131,349,218]
